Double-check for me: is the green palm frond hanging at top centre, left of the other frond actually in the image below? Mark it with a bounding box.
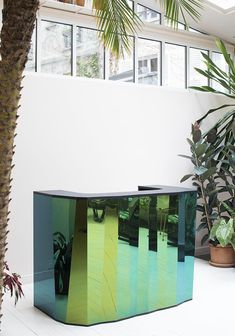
[93,0,142,57]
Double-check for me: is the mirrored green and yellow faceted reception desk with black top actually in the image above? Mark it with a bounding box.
[34,186,196,325]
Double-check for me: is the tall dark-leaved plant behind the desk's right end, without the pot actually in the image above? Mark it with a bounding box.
[180,122,235,244]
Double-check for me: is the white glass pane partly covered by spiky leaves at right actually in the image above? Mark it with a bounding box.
[189,48,208,86]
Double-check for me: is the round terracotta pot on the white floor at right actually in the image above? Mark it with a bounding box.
[209,244,235,267]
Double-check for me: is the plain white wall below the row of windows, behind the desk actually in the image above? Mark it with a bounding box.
[7,74,231,280]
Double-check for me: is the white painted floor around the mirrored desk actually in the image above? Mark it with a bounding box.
[1,259,235,336]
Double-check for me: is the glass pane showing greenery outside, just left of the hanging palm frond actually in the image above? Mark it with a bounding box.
[77,27,104,78]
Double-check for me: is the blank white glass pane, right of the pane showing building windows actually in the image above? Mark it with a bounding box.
[165,43,186,88]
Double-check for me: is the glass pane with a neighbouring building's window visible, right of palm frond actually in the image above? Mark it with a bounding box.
[138,38,161,85]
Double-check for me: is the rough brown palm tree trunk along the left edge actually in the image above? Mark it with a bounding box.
[0,0,39,320]
